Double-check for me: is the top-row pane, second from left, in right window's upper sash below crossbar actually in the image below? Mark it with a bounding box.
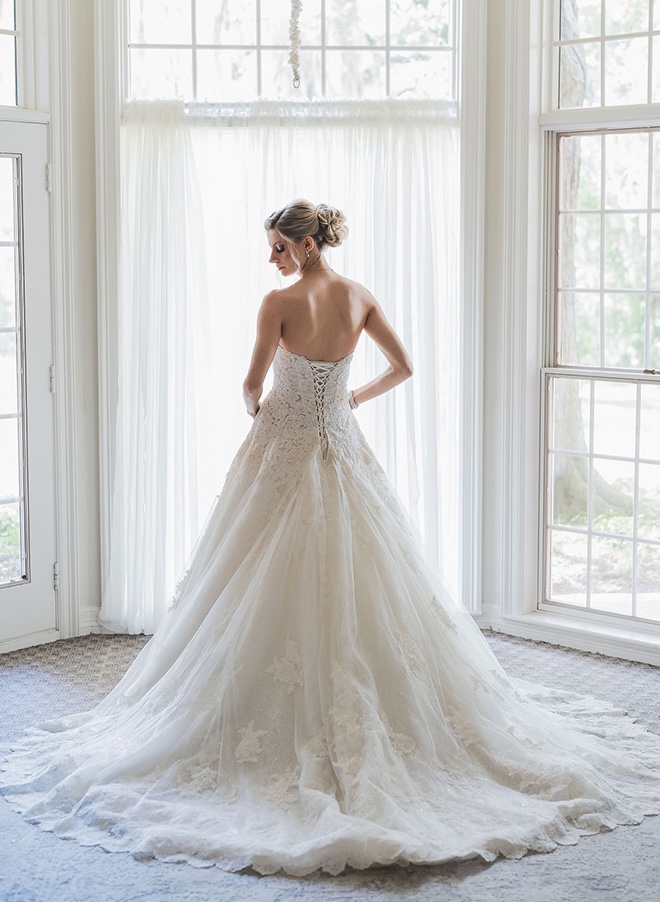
[605,132,649,210]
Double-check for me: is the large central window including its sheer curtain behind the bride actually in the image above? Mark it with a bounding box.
[102,0,464,630]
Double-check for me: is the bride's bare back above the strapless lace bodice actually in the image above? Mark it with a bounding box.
[280,270,374,360]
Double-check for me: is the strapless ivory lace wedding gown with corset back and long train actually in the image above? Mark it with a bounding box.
[0,348,660,874]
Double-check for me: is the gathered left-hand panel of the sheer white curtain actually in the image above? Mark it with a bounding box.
[99,102,217,633]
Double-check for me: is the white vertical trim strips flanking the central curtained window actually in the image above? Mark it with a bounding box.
[95,0,486,618]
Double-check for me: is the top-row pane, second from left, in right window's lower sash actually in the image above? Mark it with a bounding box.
[594,380,637,459]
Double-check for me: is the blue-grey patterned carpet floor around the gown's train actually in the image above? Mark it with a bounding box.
[0,633,660,902]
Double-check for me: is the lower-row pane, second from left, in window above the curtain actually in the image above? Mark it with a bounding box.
[197,50,257,102]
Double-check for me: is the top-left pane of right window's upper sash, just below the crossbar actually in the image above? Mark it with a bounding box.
[559,135,600,211]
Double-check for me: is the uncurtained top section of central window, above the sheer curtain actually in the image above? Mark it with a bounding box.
[126,0,456,102]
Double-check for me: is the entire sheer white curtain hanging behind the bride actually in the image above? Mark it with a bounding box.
[103,101,460,632]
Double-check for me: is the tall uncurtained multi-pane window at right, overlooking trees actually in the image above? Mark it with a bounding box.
[542,0,660,623]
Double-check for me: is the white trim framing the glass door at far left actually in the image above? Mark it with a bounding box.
[1,0,85,651]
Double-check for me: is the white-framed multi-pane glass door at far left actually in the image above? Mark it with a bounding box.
[0,121,57,650]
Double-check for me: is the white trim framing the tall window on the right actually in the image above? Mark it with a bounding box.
[490,0,660,665]
